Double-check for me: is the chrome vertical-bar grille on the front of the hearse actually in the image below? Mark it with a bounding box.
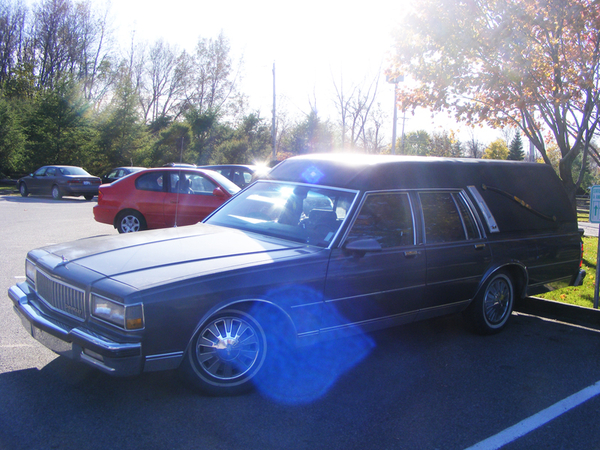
[35,270,85,320]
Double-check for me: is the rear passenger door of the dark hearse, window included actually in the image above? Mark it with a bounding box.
[418,190,492,308]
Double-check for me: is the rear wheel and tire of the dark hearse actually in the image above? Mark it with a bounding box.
[465,272,515,334]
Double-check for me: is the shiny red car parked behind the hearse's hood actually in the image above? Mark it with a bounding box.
[94,167,240,233]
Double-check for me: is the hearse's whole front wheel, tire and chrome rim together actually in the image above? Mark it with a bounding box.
[181,309,268,395]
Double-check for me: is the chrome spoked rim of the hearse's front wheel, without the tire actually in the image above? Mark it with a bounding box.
[196,316,261,382]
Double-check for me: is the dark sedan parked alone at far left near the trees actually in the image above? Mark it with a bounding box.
[18,166,102,200]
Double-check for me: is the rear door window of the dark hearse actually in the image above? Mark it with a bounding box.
[419,192,479,244]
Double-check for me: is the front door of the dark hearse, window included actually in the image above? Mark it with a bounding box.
[324,191,426,331]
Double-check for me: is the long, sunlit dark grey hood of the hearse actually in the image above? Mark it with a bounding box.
[31,224,312,289]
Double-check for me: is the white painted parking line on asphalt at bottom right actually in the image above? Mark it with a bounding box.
[466,381,600,450]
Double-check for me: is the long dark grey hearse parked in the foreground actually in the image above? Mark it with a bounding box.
[9,154,584,393]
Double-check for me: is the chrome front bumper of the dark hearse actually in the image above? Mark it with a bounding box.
[8,283,144,376]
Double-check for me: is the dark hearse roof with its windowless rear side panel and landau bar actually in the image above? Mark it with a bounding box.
[269,153,577,231]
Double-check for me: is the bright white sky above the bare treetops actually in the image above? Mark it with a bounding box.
[103,0,496,148]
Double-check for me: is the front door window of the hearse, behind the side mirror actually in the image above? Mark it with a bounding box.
[348,192,414,248]
